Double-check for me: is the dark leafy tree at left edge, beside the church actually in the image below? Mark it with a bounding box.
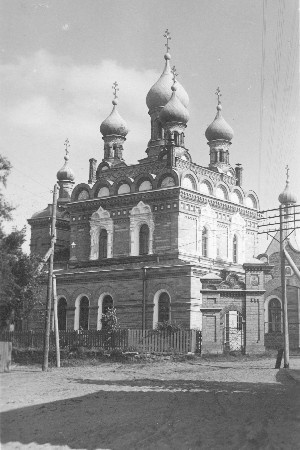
[0,155,43,329]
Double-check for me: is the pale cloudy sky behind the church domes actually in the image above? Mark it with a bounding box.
[0,0,300,250]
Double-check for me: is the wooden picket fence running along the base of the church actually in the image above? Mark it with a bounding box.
[0,329,201,354]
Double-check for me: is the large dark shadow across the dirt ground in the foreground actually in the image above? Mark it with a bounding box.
[1,371,300,450]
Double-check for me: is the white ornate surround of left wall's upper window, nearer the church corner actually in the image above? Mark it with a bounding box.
[130,201,155,256]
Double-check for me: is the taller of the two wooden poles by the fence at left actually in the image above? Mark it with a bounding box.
[42,184,57,371]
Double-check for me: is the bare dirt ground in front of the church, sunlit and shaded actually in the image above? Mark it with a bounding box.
[0,357,300,450]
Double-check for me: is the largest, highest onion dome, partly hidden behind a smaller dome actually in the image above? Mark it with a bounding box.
[146,53,189,112]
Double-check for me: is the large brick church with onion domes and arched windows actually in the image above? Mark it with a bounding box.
[28,33,271,353]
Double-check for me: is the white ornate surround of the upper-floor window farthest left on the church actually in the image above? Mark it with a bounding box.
[90,206,114,260]
